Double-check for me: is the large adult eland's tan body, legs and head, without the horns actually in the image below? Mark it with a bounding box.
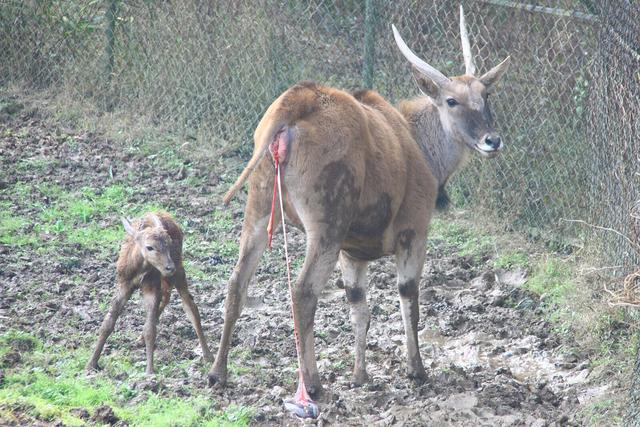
[214,32,508,397]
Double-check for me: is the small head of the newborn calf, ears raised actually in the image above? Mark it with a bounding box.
[122,214,176,277]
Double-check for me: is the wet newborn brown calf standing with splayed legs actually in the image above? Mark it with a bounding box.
[86,212,212,374]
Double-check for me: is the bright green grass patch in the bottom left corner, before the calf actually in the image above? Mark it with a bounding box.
[0,331,254,427]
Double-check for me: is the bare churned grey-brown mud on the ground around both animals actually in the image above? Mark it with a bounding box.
[0,99,599,426]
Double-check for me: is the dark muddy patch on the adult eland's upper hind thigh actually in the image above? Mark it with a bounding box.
[314,161,360,243]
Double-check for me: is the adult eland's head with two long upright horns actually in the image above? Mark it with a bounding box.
[393,6,510,157]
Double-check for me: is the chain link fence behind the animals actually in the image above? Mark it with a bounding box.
[0,0,640,267]
